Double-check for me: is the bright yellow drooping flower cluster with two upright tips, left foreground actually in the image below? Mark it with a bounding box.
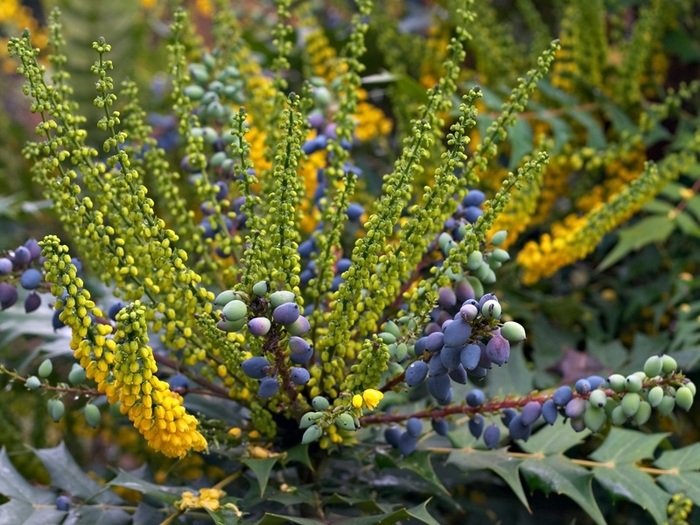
[41,236,207,457]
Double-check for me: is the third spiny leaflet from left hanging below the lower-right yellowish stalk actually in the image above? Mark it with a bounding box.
[593,465,669,524]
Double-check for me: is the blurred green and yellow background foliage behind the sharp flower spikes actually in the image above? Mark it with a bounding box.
[0,0,700,523]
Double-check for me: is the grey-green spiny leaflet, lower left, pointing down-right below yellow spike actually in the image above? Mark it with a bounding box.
[33,442,123,505]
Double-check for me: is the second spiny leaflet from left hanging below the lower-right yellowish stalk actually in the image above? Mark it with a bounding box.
[520,455,605,525]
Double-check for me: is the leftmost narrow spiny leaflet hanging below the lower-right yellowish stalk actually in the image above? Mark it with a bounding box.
[447,448,530,511]
